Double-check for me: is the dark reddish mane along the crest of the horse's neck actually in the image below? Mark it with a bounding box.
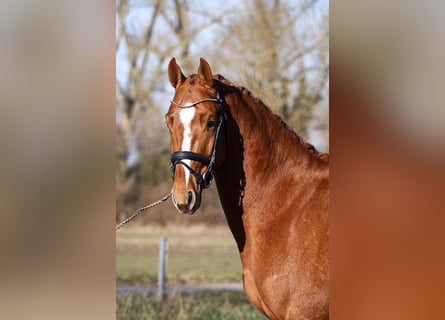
[214,74,329,162]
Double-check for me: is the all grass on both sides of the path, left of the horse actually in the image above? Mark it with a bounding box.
[116,225,266,320]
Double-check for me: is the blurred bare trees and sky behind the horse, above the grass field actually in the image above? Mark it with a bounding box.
[116,0,329,225]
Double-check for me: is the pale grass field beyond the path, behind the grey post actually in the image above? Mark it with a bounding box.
[116,226,241,285]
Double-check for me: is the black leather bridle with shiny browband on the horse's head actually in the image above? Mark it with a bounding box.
[170,89,227,190]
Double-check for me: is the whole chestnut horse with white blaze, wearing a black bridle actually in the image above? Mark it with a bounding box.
[166,58,329,320]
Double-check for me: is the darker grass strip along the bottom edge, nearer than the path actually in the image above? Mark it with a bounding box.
[116,291,266,320]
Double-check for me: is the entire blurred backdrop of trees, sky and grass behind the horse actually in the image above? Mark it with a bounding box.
[116,0,329,319]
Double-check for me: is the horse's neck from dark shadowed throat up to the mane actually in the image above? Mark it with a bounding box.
[215,84,324,252]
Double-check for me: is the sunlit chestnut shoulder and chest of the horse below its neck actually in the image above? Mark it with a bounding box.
[239,164,329,319]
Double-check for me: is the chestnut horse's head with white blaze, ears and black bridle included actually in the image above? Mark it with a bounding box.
[165,58,225,214]
